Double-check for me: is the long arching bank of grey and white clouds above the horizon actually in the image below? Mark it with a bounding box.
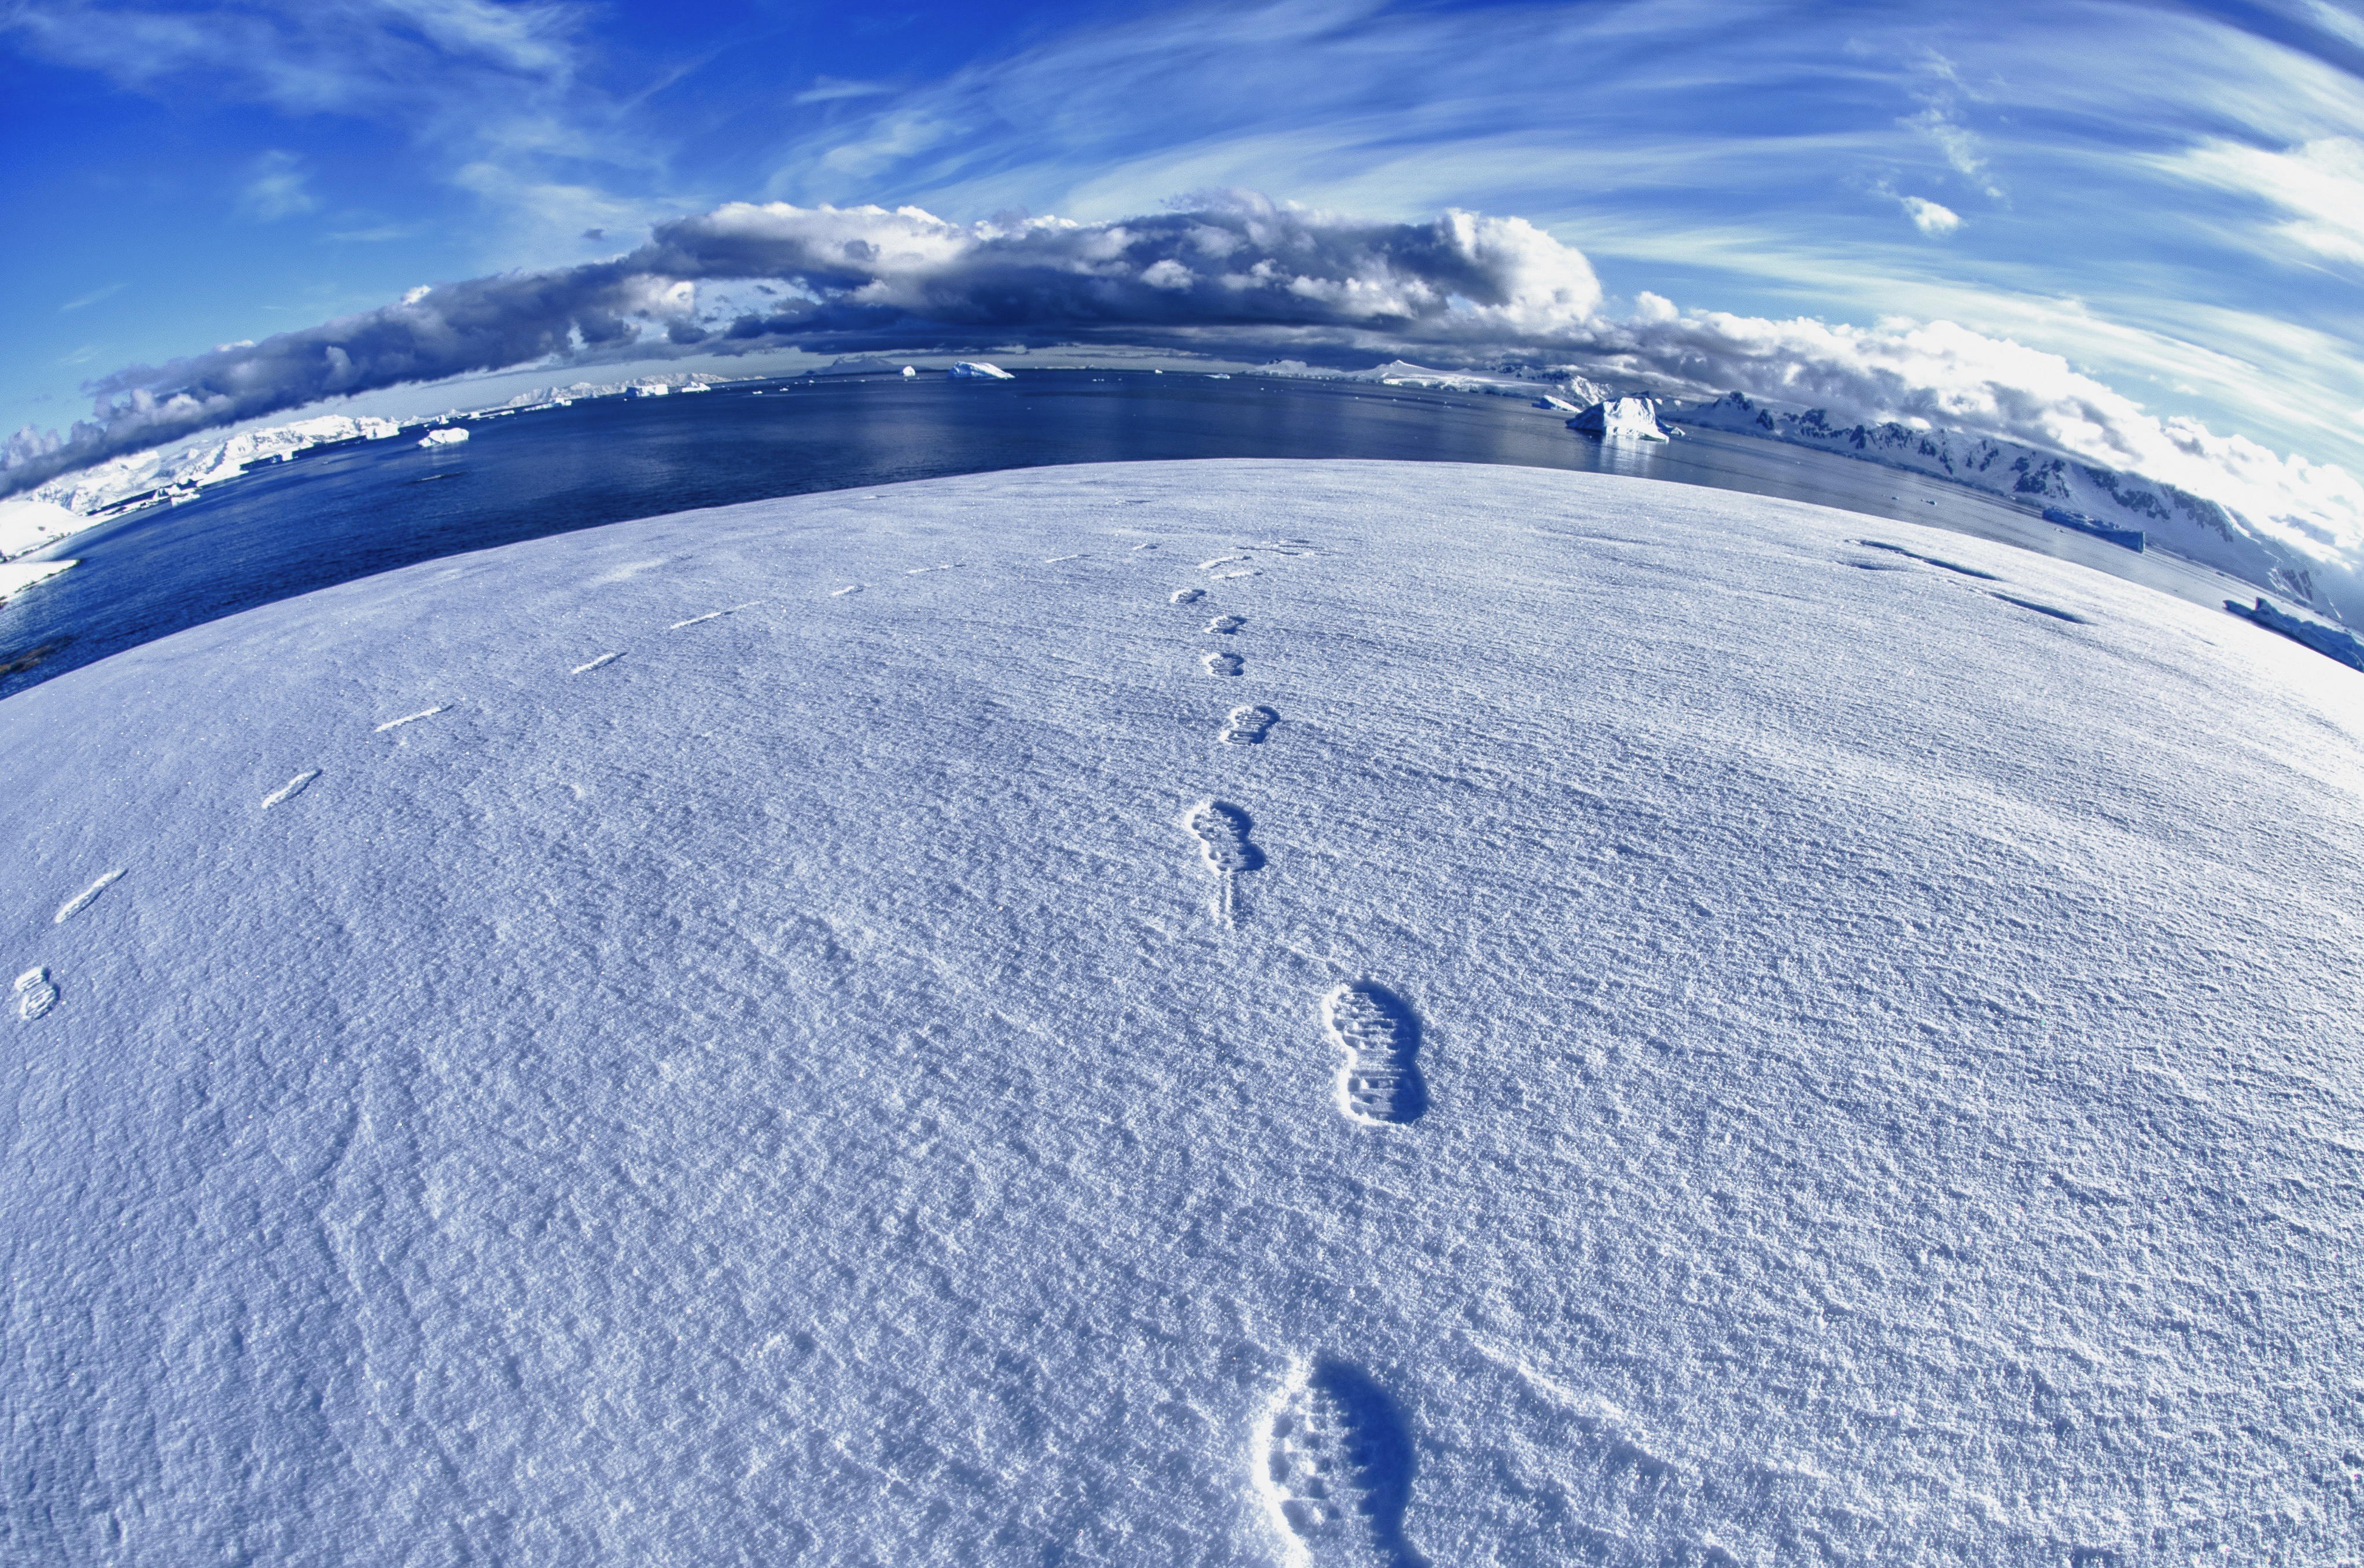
[0,194,2364,549]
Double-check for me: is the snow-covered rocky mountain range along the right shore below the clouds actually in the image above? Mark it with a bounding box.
[1667,393,2335,627]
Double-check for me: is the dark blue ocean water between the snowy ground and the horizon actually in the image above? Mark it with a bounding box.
[0,371,2238,695]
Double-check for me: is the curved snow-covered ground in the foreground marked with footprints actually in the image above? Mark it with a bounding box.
[0,461,2364,1566]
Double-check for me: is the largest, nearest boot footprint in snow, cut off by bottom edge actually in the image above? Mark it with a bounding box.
[1255,1357,1421,1568]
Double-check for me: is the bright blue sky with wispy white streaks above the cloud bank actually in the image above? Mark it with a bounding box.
[0,0,2364,499]
